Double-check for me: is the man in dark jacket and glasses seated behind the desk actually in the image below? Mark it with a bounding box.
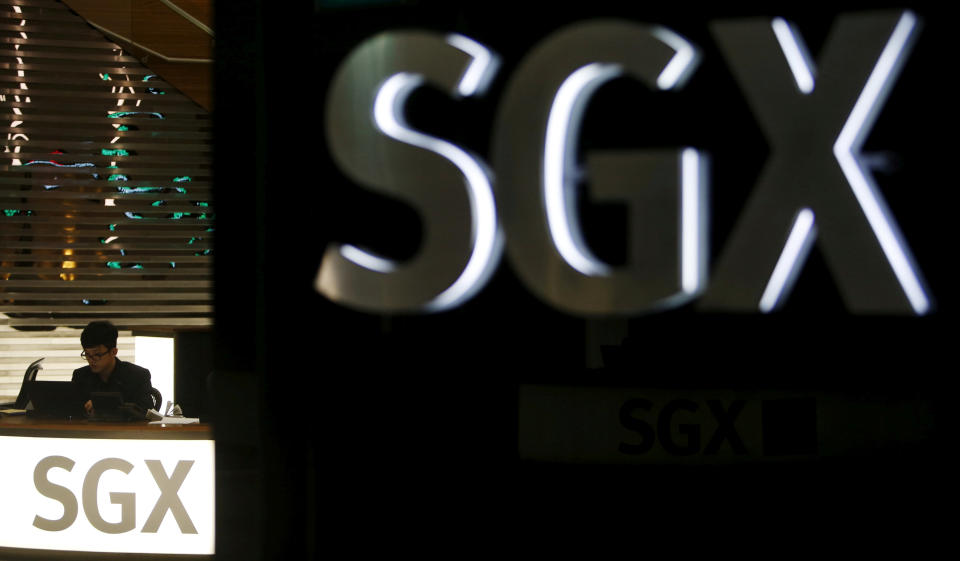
[73,321,153,415]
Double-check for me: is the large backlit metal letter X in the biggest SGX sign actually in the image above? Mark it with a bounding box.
[703,12,932,314]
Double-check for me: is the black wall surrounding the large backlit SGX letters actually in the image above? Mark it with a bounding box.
[212,0,956,559]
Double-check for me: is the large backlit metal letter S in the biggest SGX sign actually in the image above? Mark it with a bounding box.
[316,32,502,312]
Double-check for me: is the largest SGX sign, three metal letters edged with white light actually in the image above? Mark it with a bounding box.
[316,12,932,315]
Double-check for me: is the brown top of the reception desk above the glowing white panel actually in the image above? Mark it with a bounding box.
[0,415,213,440]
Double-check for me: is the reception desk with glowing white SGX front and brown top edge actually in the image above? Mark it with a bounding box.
[0,417,215,555]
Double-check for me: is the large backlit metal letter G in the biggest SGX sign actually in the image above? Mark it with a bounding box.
[493,20,706,315]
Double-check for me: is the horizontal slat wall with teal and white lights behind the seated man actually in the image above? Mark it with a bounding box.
[0,0,214,330]
